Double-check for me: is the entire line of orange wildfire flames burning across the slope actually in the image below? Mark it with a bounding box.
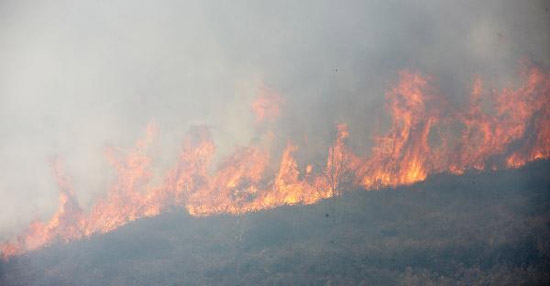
[0,64,550,258]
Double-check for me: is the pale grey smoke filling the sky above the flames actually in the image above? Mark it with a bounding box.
[0,0,550,238]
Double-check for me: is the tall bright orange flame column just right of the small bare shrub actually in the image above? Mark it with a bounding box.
[358,71,439,188]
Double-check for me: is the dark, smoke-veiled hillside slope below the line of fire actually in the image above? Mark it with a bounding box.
[0,161,550,285]
